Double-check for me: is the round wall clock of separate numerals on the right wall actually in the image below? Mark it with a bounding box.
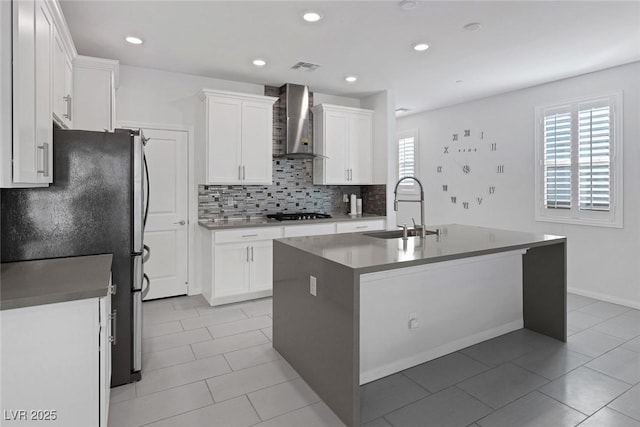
[436,129,506,210]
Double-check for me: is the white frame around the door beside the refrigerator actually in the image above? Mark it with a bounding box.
[117,120,202,295]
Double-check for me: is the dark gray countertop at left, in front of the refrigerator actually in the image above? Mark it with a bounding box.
[0,254,113,310]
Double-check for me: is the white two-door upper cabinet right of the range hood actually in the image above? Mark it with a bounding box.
[311,104,373,185]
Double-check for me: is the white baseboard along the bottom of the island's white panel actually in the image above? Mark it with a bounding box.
[360,320,524,385]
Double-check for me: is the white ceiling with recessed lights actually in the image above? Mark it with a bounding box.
[61,0,640,112]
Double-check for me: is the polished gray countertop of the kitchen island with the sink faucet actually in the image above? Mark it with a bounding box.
[275,224,566,273]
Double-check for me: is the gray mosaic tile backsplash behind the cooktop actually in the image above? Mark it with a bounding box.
[198,159,386,221]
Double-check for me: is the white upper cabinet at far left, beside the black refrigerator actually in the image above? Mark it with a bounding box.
[0,0,75,188]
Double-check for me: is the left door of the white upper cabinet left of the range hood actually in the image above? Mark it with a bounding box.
[206,97,242,184]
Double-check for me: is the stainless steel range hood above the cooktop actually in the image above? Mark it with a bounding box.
[275,83,318,159]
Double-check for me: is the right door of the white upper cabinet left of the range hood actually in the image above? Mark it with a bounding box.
[241,101,273,185]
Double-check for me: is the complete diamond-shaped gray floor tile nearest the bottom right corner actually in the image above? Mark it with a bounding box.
[539,367,630,415]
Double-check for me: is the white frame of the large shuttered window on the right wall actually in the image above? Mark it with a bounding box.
[535,91,624,228]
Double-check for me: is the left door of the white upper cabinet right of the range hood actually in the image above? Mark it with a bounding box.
[324,111,349,184]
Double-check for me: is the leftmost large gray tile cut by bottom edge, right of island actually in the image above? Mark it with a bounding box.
[385,387,491,427]
